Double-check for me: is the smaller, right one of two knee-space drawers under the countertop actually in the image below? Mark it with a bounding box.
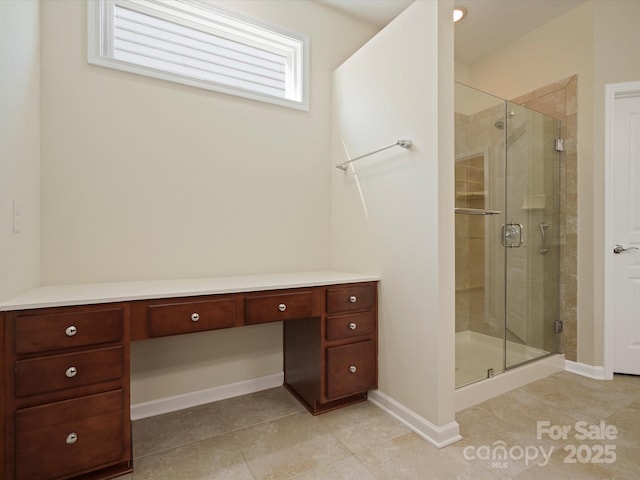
[245,290,317,324]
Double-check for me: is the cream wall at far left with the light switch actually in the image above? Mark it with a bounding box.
[0,0,40,300]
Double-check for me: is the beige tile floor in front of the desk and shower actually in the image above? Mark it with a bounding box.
[122,372,640,480]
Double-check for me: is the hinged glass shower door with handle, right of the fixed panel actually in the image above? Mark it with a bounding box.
[503,103,560,368]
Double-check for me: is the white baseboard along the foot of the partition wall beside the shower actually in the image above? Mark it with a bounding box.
[369,390,462,448]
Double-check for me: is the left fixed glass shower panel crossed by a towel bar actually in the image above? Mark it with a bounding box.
[455,83,506,387]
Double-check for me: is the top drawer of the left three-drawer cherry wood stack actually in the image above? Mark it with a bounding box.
[15,307,123,355]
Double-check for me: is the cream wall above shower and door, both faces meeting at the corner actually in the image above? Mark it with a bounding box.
[461,0,640,365]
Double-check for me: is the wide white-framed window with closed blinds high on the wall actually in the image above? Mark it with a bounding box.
[89,0,308,110]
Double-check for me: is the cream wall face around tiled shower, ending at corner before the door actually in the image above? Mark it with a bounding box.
[465,2,602,364]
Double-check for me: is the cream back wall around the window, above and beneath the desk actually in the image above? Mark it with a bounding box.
[37,0,376,404]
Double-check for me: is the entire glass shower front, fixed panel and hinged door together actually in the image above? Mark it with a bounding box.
[455,83,560,387]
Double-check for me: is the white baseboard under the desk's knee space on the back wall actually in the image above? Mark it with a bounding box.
[131,373,284,420]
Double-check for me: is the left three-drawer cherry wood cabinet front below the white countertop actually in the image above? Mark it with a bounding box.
[0,303,132,480]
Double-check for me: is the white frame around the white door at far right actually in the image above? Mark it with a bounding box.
[603,82,640,380]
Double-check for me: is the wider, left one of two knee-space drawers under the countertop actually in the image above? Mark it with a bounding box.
[147,298,236,337]
